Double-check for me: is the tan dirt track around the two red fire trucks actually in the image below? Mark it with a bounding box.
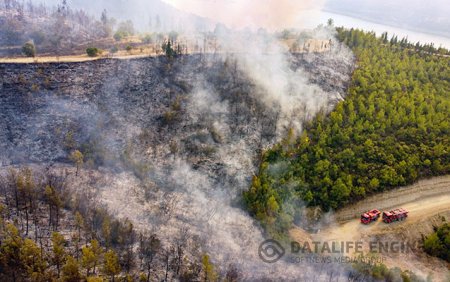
[291,175,450,281]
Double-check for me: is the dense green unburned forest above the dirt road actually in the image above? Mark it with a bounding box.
[244,28,450,234]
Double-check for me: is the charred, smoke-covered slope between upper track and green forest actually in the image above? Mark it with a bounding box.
[0,50,353,278]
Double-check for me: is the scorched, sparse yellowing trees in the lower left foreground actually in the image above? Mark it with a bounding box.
[0,168,240,281]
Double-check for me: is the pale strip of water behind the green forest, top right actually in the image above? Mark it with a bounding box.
[300,11,450,49]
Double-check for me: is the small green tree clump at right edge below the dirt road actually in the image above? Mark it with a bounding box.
[423,223,450,262]
